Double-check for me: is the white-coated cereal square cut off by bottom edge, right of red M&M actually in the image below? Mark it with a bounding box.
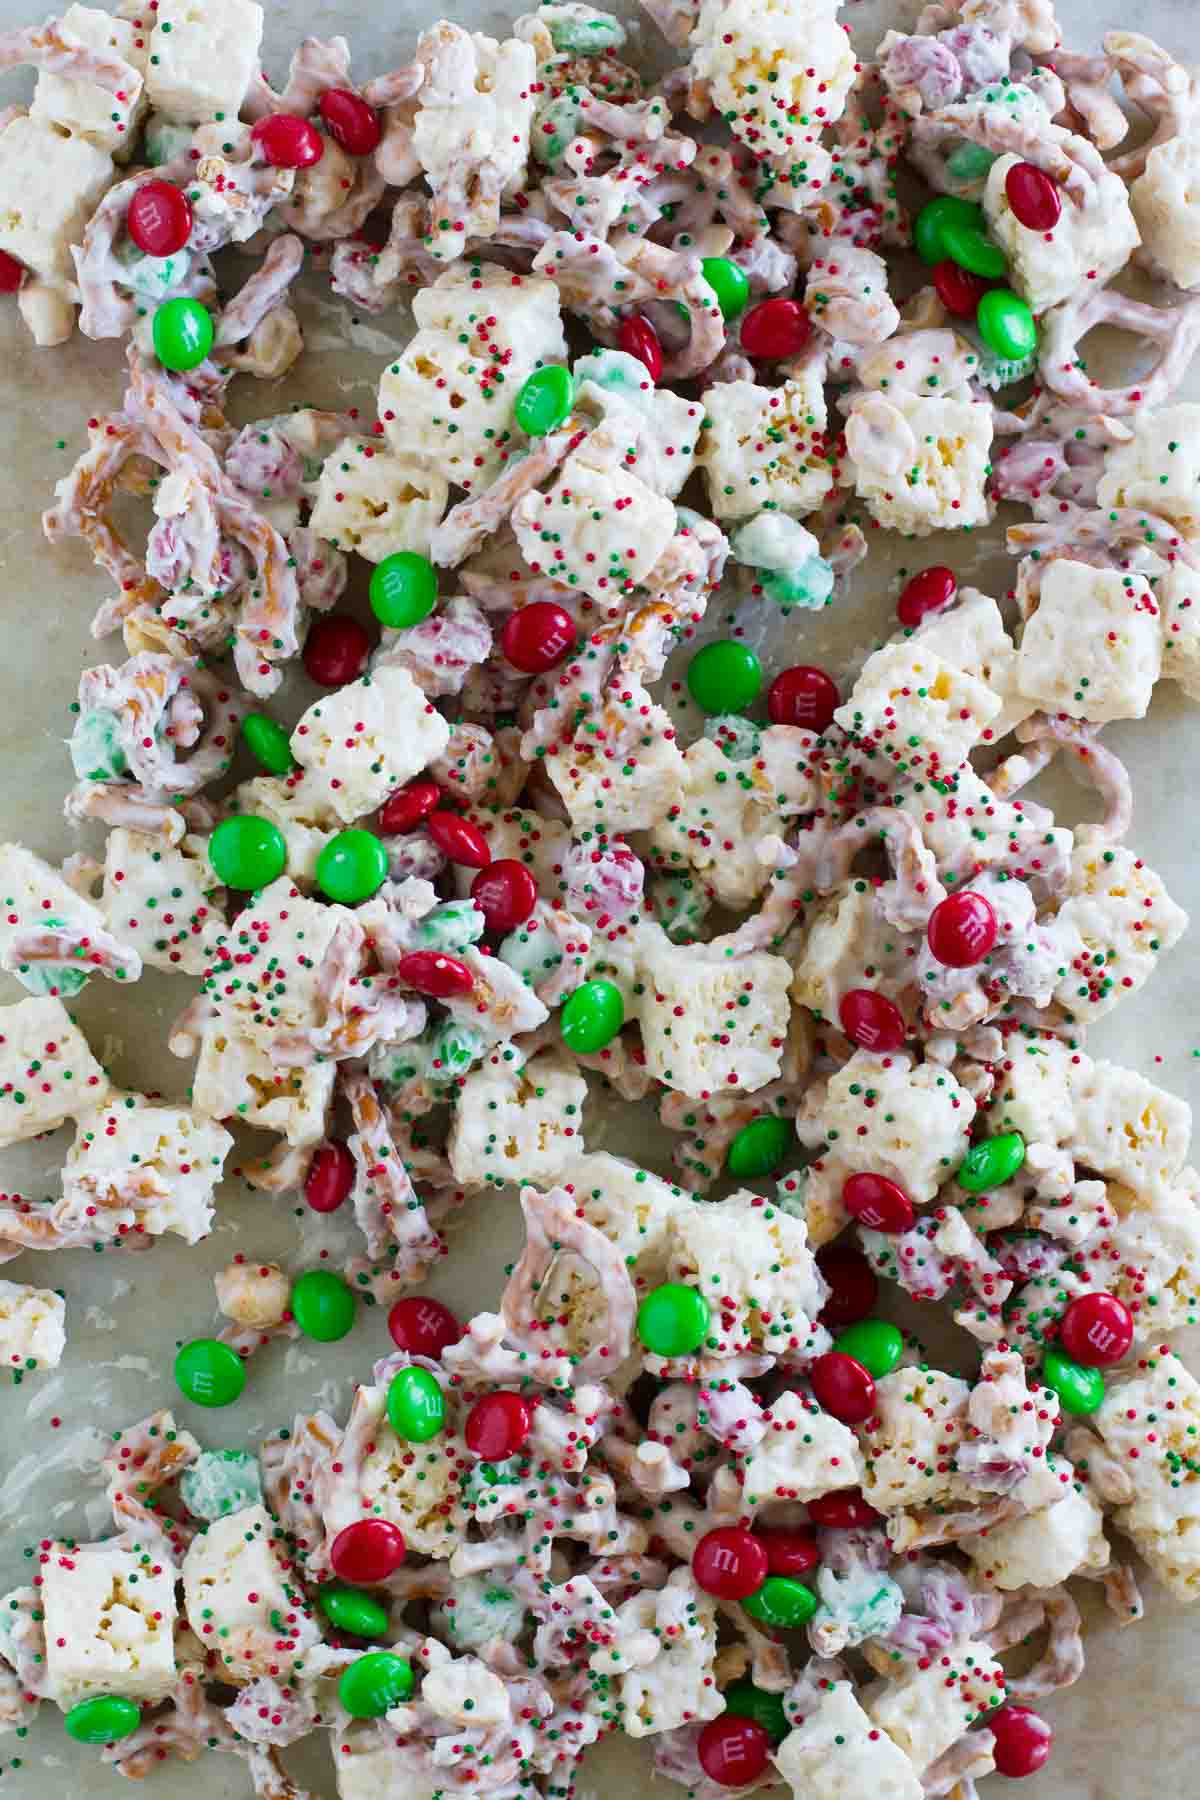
[772,1681,925,1800]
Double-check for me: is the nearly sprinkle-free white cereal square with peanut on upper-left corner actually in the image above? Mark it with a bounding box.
[846,389,995,538]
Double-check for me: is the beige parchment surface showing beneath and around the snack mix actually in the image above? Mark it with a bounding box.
[0,0,1200,1800]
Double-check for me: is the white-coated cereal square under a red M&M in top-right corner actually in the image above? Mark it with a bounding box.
[982,151,1139,313]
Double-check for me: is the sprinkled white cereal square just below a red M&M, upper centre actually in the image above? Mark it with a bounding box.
[696,367,833,518]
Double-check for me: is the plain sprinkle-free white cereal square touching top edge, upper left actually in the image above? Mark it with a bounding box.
[146,0,263,124]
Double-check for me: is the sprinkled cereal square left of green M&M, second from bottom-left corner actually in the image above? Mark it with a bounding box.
[184,1505,320,1681]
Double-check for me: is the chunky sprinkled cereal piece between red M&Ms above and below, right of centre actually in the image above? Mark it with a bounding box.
[795,1049,975,1204]
